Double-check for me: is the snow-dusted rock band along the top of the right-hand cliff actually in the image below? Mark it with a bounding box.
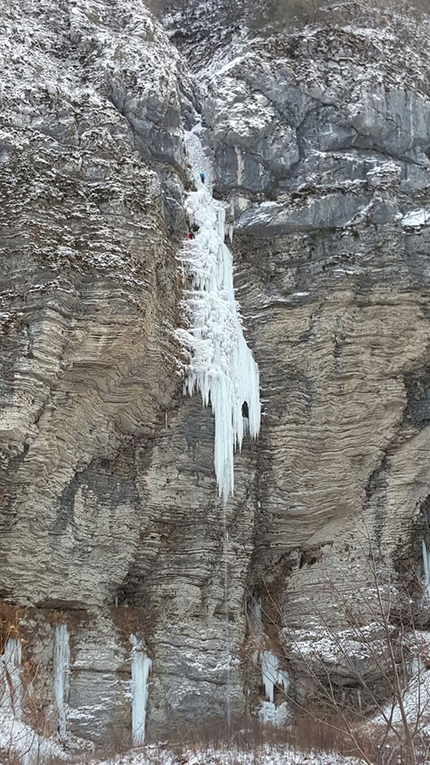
[197,4,430,106]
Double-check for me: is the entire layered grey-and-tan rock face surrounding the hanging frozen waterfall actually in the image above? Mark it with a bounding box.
[0,0,430,746]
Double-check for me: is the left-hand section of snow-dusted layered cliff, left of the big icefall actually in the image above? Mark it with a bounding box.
[0,0,185,748]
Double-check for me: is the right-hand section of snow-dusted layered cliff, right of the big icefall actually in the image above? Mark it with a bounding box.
[199,1,430,708]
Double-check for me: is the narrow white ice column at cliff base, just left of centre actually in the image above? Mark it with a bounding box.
[130,635,152,746]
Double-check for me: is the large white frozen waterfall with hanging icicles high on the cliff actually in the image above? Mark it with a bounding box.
[180,124,260,502]
